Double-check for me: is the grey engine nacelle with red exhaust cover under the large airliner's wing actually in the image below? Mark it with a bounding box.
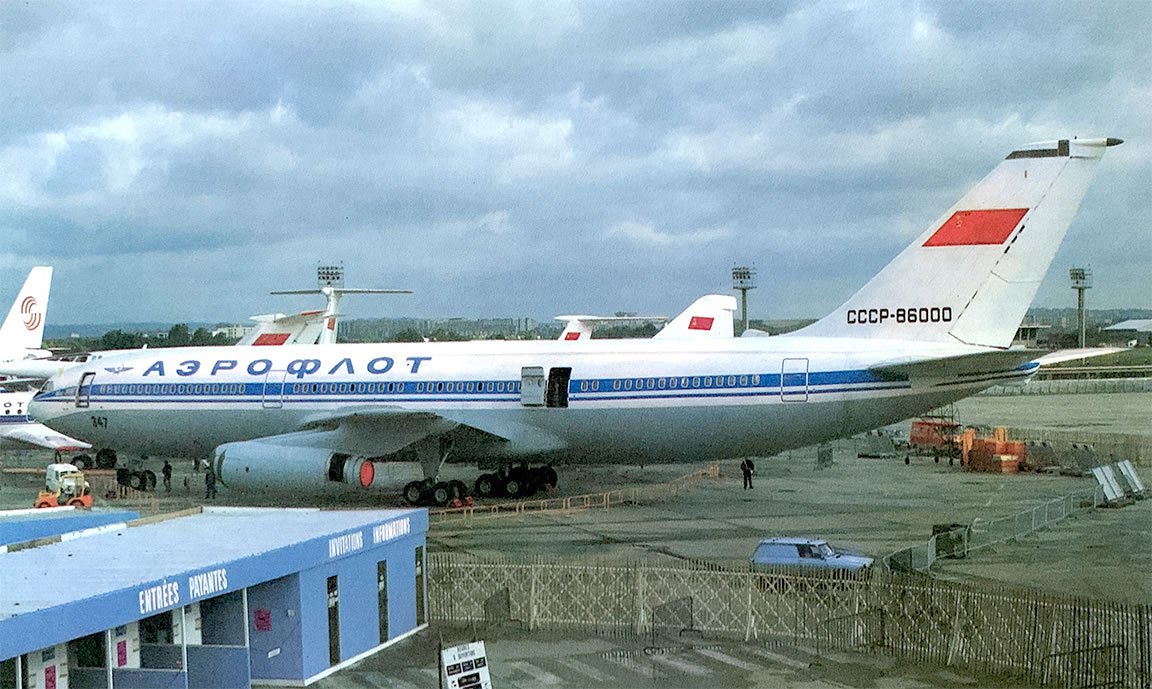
[212,441,391,492]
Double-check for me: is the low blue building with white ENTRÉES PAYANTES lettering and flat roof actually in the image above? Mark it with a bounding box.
[0,507,427,689]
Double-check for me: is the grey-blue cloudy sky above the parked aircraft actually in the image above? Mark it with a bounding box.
[0,0,1152,324]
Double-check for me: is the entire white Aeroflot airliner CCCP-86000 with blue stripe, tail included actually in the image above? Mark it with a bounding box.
[31,138,1121,504]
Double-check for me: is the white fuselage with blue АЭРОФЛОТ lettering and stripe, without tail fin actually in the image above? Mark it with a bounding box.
[32,336,1026,462]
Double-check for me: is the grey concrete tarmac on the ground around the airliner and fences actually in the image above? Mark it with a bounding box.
[0,393,1152,689]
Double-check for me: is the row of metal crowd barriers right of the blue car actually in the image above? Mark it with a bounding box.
[881,486,1106,571]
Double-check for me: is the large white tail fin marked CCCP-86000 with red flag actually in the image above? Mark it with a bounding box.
[789,138,1122,348]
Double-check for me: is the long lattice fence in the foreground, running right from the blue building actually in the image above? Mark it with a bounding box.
[430,553,1152,688]
